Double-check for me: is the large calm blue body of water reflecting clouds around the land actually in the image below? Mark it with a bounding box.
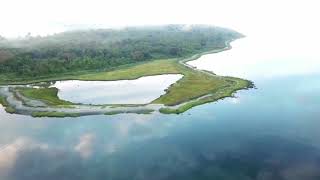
[0,37,320,180]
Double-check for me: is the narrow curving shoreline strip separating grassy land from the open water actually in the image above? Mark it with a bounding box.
[0,39,253,117]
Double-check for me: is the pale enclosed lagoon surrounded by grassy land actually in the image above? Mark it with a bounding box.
[52,74,182,104]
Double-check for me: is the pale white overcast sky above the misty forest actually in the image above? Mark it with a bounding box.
[0,0,320,37]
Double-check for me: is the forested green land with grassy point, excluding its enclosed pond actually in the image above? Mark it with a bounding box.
[0,25,253,117]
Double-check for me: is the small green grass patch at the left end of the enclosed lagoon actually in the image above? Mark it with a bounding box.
[17,87,73,107]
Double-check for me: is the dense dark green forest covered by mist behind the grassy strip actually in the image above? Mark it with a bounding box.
[0,25,242,78]
